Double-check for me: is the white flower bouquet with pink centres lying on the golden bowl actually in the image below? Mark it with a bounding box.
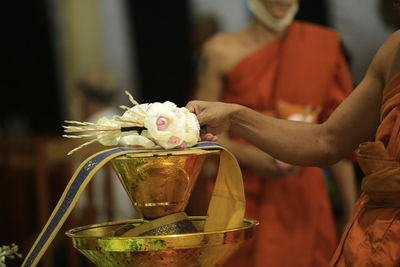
[63,92,200,154]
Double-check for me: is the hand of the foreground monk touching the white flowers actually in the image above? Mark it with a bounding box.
[186,100,240,141]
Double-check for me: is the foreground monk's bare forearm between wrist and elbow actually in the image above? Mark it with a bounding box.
[231,106,341,166]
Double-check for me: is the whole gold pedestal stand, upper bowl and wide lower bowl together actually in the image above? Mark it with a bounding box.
[66,149,258,267]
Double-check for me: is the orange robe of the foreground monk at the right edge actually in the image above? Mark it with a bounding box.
[330,73,400,266]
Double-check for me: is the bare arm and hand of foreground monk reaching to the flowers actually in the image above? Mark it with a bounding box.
[187,30,399,166]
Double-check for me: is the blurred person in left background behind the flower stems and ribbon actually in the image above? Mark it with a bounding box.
[74,68,138,223]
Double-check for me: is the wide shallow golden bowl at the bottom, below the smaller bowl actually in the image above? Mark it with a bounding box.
[66,216,259,267]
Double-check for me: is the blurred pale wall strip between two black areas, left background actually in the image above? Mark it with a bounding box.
[47,0,140,119]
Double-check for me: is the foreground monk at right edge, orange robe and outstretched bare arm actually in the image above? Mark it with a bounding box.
[187,0,400,266]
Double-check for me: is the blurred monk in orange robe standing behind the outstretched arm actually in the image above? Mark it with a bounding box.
[195,0,356,267]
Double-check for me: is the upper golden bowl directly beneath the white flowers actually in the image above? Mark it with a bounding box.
[111,149,219,219]
